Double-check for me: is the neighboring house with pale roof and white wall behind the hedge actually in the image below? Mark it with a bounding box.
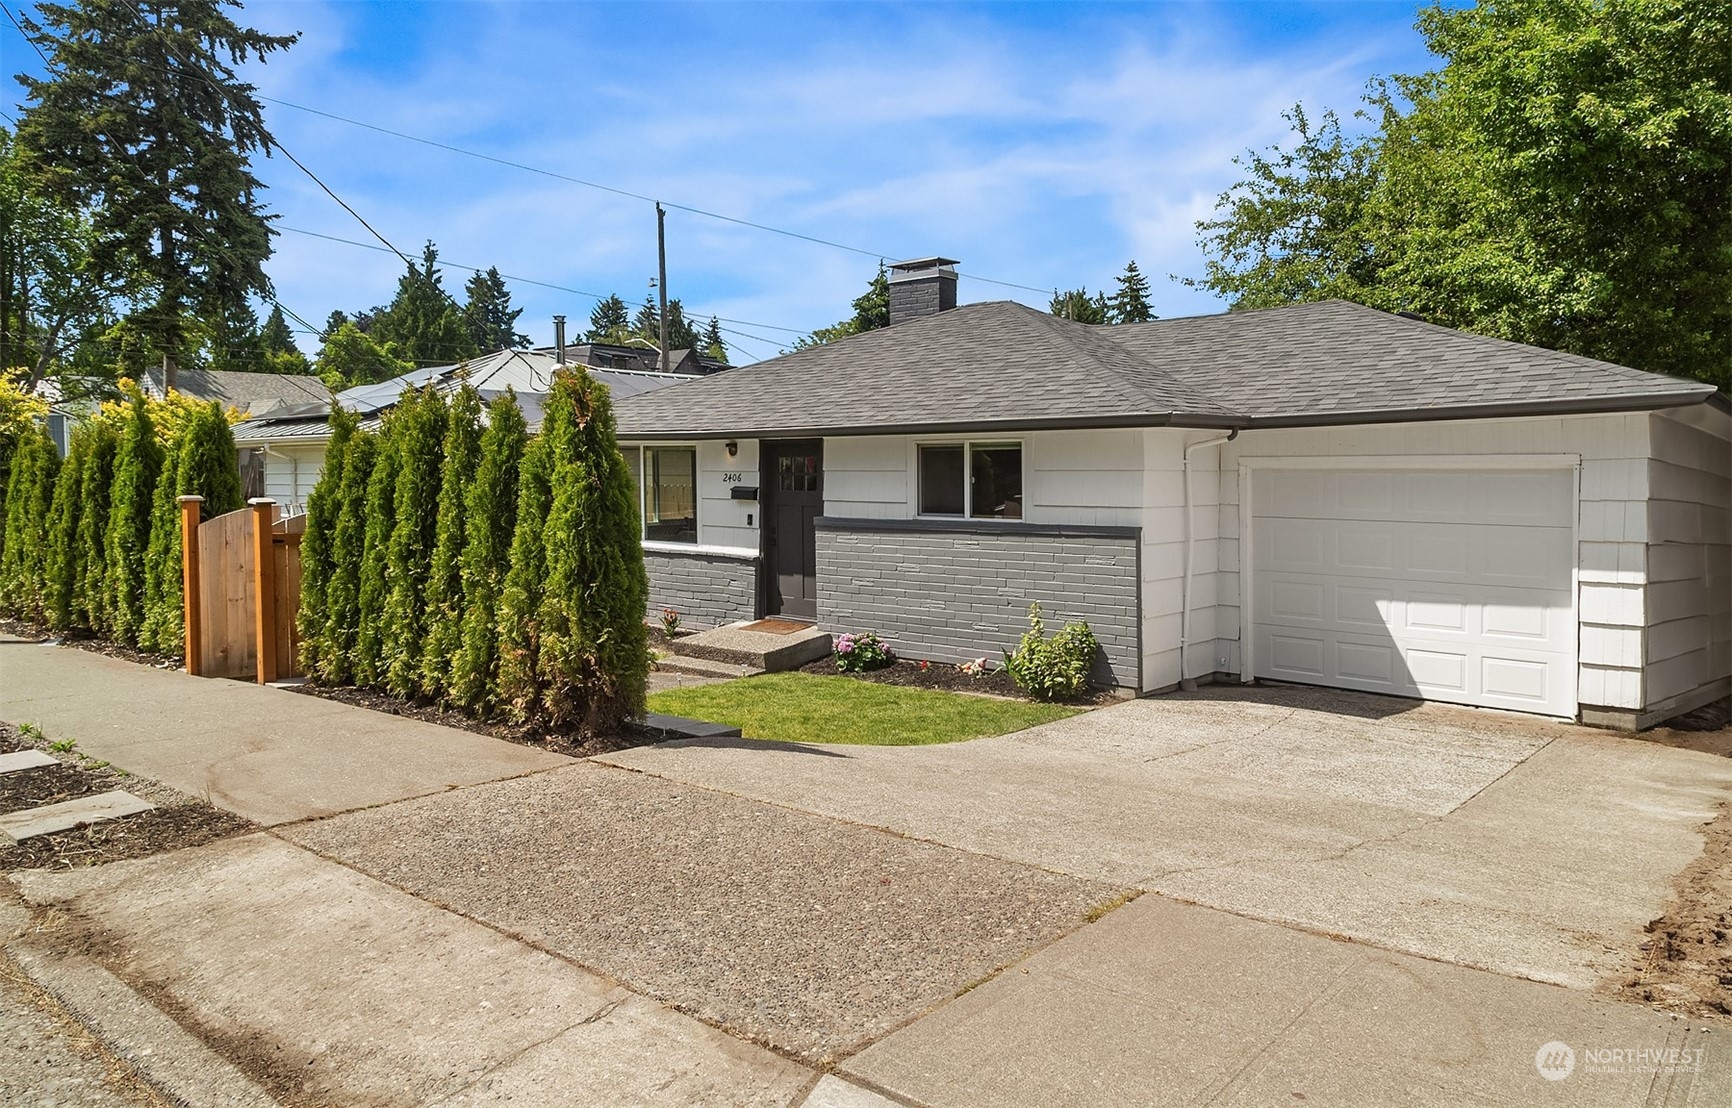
[227,350,691,512]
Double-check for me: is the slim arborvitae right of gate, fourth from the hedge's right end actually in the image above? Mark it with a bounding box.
[419,384,481,698]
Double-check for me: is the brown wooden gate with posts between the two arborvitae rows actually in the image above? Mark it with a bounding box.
[180,497,307,684]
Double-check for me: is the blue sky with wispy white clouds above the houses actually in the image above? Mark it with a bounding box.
[3,0,1429,362]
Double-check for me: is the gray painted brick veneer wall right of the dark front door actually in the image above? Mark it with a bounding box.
[818,518,1141,689]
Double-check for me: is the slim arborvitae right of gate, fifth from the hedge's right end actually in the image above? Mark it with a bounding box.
[383,388,449,696]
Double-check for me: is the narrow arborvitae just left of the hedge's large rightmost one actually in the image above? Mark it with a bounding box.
[494,424,554,724]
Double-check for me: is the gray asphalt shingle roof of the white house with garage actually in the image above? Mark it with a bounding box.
[618,300,1715,438]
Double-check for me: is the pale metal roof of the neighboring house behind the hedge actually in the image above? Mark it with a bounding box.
[234,350,695,445]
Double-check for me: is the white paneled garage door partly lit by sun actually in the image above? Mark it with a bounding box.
[1251,469,1576,715]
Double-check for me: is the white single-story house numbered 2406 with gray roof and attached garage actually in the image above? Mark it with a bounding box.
[617,258,1732,727]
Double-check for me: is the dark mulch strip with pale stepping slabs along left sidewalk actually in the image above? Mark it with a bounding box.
[0,724,258,871]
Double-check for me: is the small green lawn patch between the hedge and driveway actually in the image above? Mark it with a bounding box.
[650,673,1077,746]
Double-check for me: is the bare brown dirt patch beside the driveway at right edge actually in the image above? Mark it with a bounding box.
[1619,805,1732,1018]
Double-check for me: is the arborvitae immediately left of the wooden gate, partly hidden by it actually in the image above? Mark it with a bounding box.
[140,400,246,654]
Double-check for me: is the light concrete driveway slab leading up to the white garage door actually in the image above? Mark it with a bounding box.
[606,689,1732,989]
